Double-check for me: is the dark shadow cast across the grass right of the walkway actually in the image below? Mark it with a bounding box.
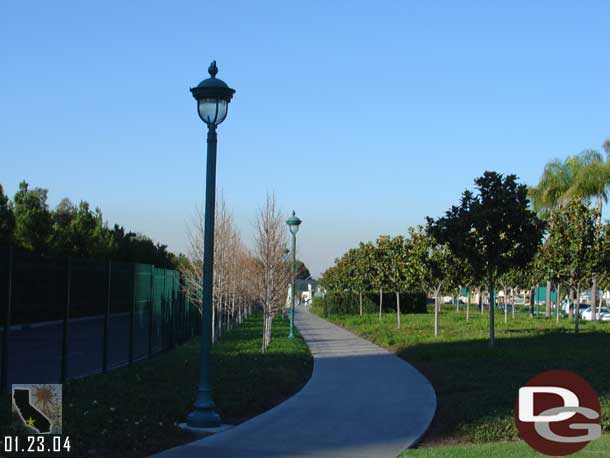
[397,329,610,444]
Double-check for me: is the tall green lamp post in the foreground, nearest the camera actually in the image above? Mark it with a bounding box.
[187,61,235,428]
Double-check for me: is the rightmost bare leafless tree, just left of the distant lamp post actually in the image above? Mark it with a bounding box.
[254,194,290,353]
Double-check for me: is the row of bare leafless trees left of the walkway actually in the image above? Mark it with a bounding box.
[180,194,310,352]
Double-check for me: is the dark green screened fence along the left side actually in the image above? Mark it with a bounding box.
[0,246,200,388]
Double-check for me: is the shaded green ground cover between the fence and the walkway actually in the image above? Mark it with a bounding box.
[0,315,313,458]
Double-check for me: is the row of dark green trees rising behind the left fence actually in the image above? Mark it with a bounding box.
[0,181,179,267]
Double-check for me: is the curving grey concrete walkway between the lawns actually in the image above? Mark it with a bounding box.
[155,307,436,458]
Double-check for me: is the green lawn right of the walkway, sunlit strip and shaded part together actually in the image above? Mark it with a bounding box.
[314,306,610,448]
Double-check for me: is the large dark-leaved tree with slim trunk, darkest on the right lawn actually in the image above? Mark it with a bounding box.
[427,172,544,345]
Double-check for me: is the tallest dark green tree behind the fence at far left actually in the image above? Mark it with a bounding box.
[13,181,52,253]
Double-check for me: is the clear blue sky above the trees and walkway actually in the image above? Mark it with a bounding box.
[0,0,610,274]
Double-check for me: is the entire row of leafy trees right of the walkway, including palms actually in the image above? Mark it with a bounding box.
[322,142,610,344]
